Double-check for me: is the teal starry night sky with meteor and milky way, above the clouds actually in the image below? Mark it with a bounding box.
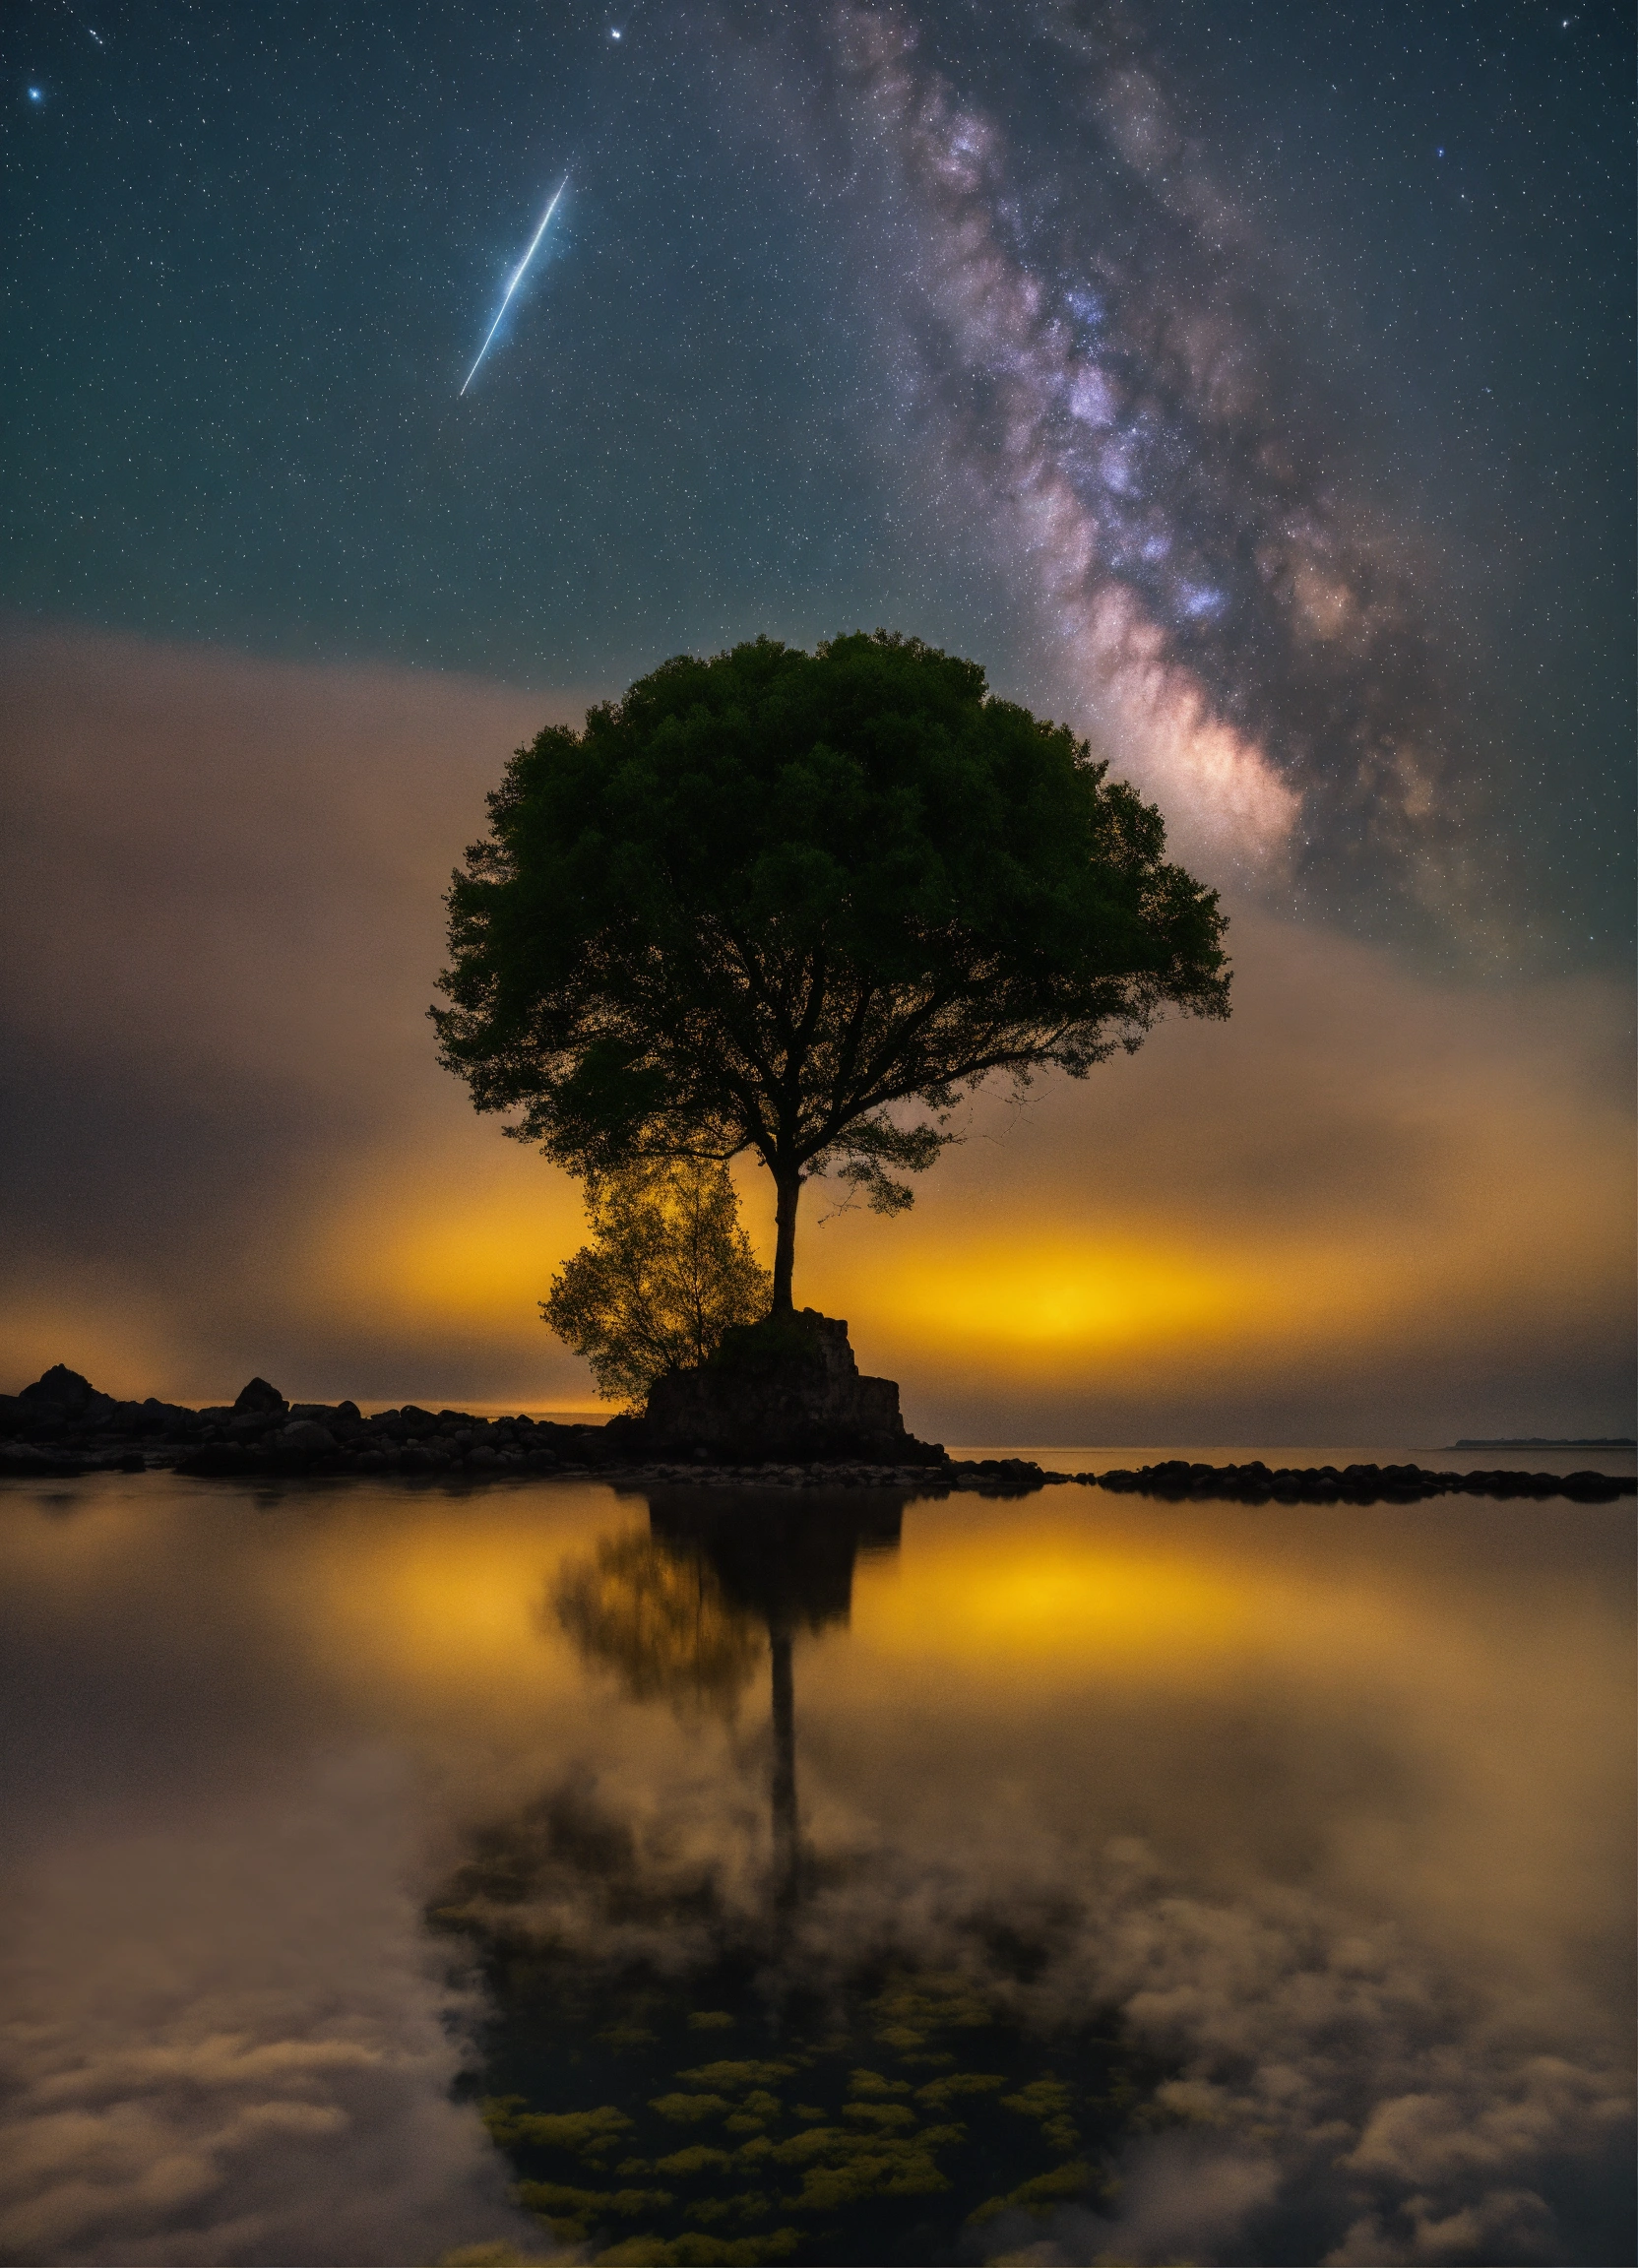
[0,0,1633,1390]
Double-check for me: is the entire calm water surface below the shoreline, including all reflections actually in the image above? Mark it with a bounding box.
[0,1449,1633,2268]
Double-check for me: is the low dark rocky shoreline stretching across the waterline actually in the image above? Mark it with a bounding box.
[0,1363,1638,1504]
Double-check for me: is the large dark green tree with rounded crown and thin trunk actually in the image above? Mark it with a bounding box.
[433,631,1228,1313]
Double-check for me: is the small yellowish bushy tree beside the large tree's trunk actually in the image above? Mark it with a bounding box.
[540,1159,774,1406]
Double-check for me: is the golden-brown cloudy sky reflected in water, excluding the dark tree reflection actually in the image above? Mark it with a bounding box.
[0,1479,1631,2261]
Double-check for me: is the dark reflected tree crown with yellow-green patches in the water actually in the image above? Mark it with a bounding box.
[431,1794,1173,2268]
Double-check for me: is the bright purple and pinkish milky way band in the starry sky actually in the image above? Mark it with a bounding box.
[734,0,1481,943]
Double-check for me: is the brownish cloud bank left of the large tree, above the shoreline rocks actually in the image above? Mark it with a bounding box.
[0,612,590,1404]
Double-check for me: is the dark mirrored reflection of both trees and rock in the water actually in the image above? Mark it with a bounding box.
[431,1490,1179,2263]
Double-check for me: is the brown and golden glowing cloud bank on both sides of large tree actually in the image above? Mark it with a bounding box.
[0,633,1633,1442]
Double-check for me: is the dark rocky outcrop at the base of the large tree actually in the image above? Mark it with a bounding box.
[645,1306,944,1465]
